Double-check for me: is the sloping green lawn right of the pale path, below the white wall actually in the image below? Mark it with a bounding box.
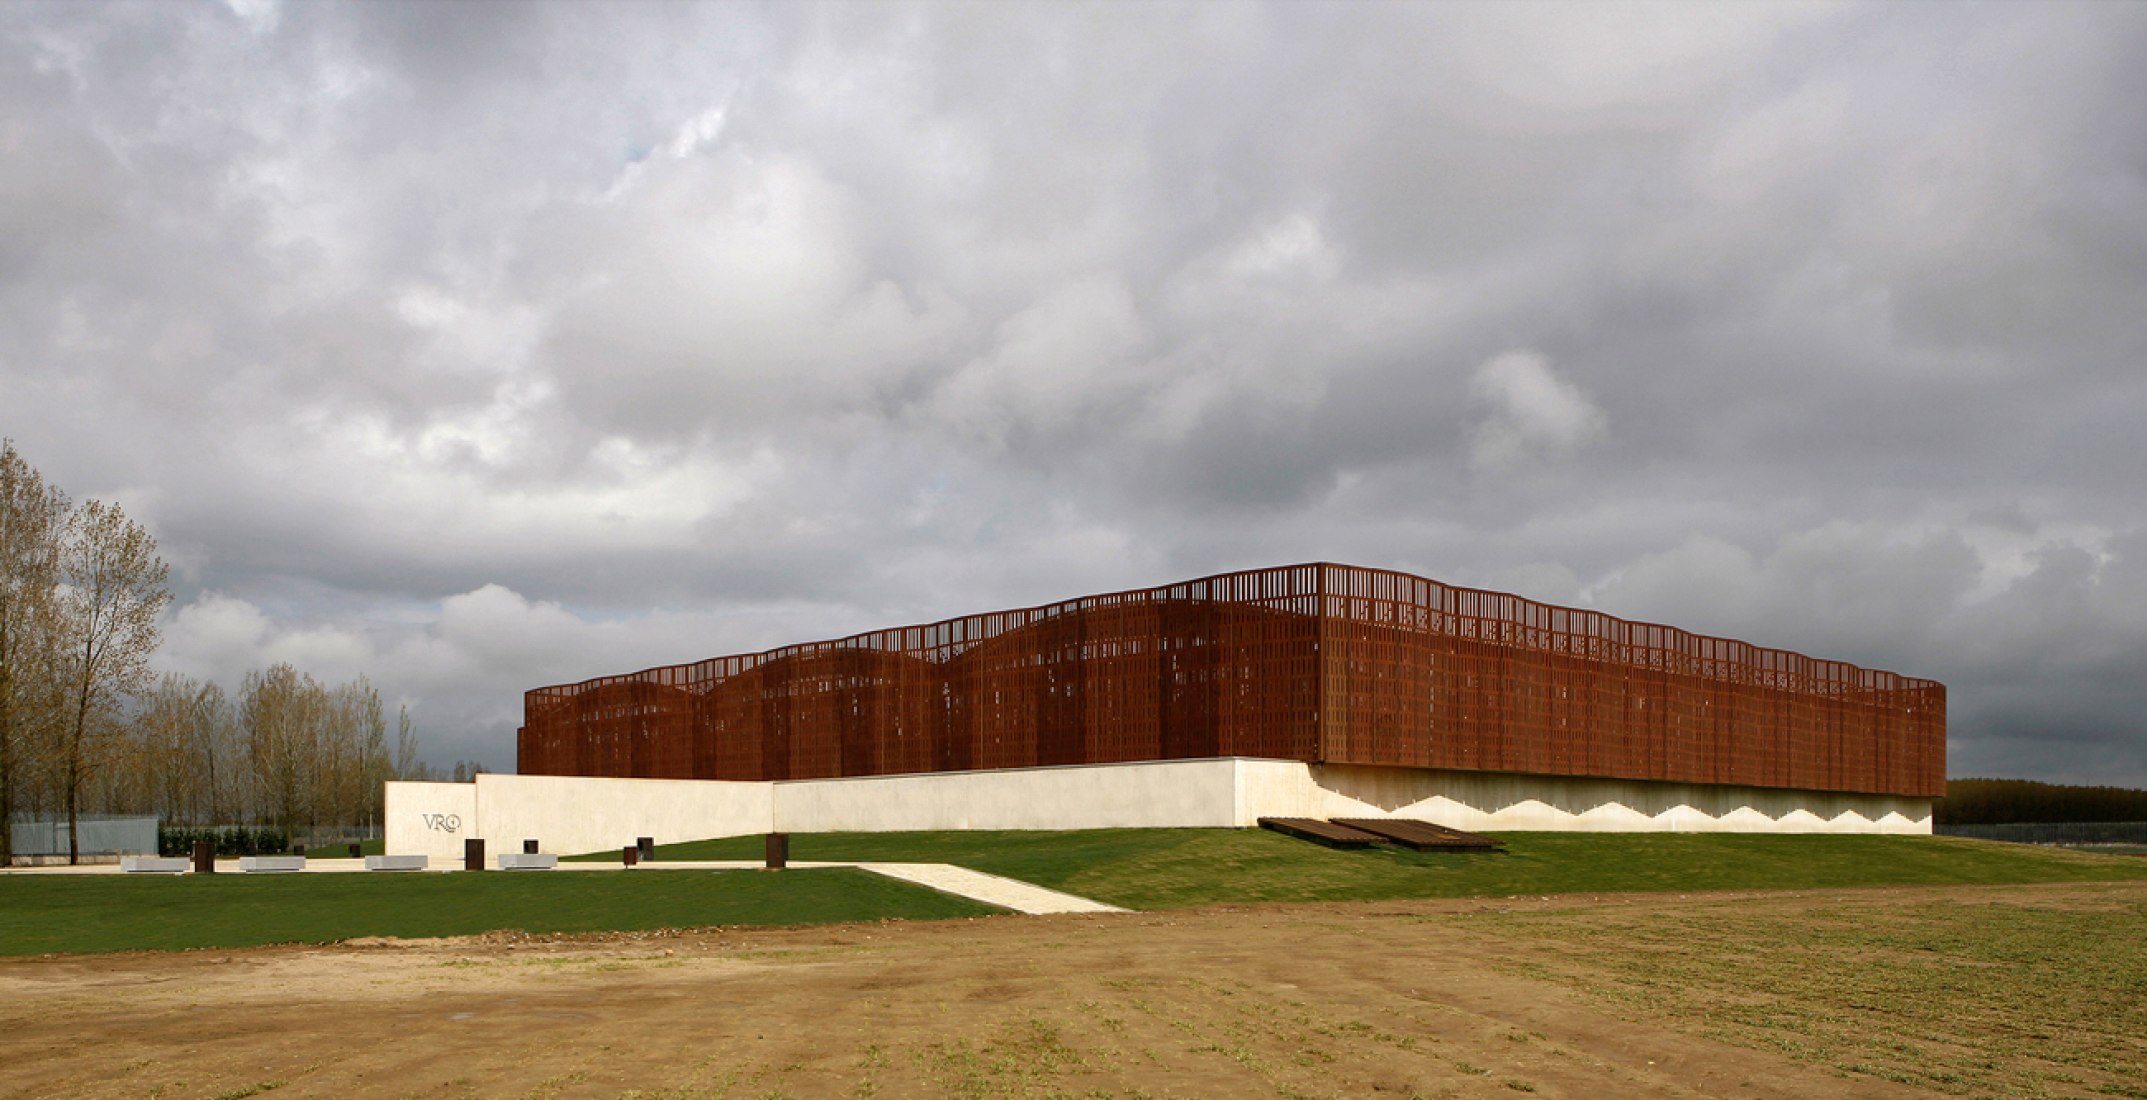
[588,829,2147,909]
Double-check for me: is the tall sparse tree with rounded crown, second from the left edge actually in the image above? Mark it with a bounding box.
[54,501,172,864]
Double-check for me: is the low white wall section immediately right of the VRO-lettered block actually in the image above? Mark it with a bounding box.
[476,773,775,857]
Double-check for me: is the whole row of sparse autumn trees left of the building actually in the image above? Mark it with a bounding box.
[0,440,446,862]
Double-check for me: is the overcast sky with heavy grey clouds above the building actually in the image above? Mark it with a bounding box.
[0,0,2147,786]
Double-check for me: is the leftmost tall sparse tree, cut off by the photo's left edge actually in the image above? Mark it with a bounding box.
[0,440,67,866]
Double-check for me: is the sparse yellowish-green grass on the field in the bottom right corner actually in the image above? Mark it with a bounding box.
[1459,887,2147,1098]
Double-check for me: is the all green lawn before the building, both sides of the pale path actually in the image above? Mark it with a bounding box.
[0,829,2147,954]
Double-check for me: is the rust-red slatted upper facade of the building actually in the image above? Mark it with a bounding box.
[517,563,1945,797]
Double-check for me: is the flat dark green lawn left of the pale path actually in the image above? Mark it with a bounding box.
[0,870,998,954]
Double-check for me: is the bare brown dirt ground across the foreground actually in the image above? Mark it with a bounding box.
[0,887,2065,1100]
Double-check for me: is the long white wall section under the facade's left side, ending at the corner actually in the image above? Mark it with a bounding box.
[775,758,1241,834]
